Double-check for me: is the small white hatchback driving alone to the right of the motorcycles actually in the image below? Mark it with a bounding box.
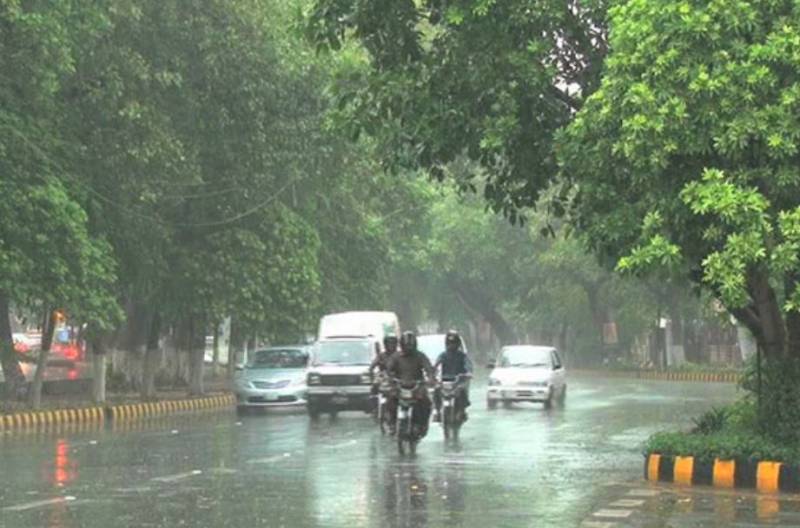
[486,345,567,409]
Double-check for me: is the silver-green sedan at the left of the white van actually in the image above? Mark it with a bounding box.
[235,346,308,409]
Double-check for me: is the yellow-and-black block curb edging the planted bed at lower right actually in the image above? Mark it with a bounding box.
[644,453,800,493]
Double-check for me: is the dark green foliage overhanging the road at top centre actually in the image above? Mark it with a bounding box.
[307,0,606,219]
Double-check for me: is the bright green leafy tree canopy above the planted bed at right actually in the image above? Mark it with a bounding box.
[561,0,800,364]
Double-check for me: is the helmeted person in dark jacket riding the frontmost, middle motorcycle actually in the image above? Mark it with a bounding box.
[386,332,436,436]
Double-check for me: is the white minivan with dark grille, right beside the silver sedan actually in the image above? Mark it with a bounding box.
[306,337,380,418]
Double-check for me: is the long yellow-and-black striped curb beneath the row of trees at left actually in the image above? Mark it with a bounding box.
[0,394,236,433]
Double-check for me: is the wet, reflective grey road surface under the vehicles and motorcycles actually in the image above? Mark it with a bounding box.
[0,378,764,528]
